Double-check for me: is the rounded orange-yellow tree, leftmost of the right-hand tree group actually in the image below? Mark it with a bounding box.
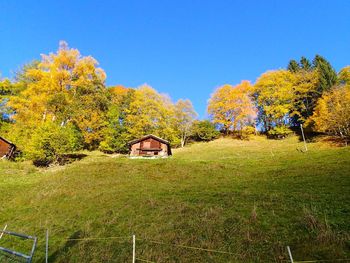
[208,81,256,133]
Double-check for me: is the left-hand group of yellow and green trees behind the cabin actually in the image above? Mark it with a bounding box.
[0,42,218,163]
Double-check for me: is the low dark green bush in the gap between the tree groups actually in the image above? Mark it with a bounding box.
[191,120,220,141]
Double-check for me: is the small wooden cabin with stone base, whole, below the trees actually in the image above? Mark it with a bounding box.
[129,134,171,157]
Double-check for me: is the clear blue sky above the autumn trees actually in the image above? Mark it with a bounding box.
[0,0,350,117]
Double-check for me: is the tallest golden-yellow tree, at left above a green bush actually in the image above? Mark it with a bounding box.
[9,41,108,161]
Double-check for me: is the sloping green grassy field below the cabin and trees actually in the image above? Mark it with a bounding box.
[0,137,350,262]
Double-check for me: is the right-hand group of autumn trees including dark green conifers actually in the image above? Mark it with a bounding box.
[208,55,350,140]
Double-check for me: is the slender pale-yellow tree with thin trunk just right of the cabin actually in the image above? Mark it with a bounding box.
[174,99,197,147]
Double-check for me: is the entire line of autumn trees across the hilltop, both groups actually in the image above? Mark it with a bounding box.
[0,41,350,163]
